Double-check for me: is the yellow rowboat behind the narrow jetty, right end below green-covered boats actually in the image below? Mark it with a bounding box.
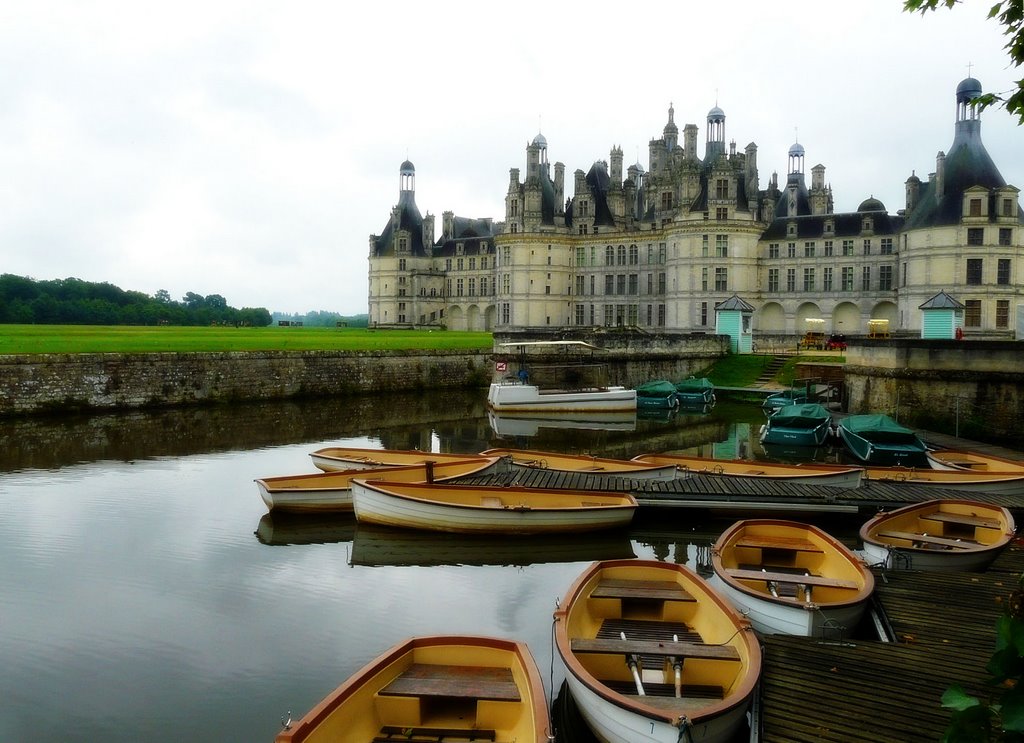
[633,453,863,487]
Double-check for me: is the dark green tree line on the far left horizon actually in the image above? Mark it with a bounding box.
[0,273,270,327]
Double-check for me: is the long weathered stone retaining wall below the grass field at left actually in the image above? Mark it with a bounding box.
[0,351,490,416]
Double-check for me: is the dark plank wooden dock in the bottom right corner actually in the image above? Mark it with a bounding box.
[758,541,1024,743]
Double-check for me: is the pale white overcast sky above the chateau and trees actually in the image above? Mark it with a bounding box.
[0,0,1024,314]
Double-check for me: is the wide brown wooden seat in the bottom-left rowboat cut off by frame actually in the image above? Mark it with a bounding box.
[378,663,520,702]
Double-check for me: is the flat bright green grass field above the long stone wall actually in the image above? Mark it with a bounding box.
[0,325,492,354]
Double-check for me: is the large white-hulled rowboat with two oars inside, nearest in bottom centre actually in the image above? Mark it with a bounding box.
[555,560,761,743]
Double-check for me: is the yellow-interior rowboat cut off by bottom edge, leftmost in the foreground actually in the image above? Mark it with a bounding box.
[274,636,551,743]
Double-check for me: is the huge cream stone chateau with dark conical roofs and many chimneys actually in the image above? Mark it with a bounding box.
[369,78,1024,337]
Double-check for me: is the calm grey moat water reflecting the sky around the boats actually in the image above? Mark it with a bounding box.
[0,391,855,743]
